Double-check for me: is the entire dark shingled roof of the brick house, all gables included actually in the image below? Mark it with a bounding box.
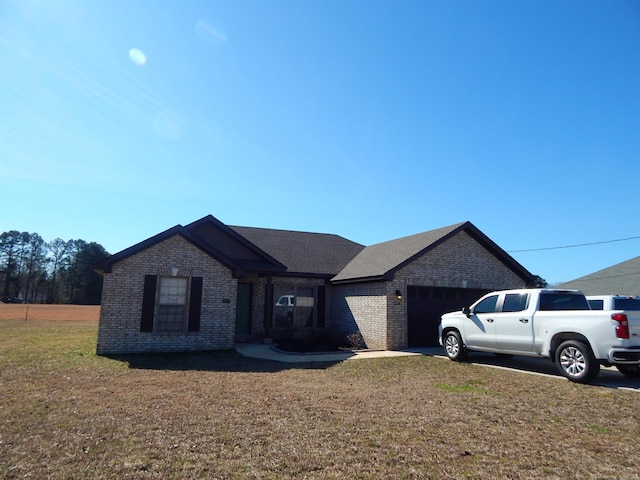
[94,215,533,283]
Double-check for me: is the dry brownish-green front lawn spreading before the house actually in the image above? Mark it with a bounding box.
[0,306,640,479]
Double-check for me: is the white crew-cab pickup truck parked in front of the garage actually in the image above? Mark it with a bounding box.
[439,289,640,383]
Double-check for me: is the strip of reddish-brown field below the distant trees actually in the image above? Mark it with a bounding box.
[0,303,100,322]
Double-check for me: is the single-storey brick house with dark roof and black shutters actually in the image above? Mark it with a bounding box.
[95,215,534,354]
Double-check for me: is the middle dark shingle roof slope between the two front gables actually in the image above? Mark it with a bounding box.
[229,226,364,276]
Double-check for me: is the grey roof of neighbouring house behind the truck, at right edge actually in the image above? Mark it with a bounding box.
[558,257,640,296]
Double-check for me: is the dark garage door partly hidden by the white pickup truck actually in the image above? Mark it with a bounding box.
[407,286,489,348]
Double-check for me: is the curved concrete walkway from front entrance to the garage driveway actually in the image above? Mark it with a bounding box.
[234,343,444,363]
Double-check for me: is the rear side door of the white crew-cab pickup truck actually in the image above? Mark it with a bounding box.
[494,293,533,352]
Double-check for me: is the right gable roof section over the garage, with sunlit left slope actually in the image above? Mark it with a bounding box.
[331,222,533,283]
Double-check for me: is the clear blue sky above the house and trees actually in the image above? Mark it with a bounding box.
[0,0,640,282]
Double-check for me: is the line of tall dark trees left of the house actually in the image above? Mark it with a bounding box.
[0,230,109,305]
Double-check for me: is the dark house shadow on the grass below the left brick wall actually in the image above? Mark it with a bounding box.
[105,350,341,373]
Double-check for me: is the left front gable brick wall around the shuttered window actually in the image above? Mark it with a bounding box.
[96,235,237,354]
